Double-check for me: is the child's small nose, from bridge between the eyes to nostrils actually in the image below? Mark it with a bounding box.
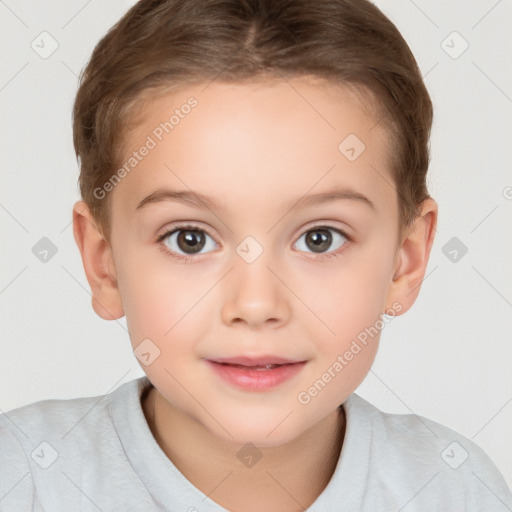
[222,236,289,326]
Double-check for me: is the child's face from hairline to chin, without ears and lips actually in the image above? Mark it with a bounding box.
[98,79,409,446]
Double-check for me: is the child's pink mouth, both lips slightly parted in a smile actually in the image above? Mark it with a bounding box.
[206,356,306,391]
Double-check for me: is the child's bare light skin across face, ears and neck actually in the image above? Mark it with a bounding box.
[73,78,437,512]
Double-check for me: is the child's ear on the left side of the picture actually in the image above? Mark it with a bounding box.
[73,201,124,320]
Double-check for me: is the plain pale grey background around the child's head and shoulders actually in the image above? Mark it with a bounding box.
[0,0,512,485]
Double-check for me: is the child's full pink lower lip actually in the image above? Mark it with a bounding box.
[206,360,306,391]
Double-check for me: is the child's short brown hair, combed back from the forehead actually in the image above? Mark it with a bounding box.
[73,0,433,243]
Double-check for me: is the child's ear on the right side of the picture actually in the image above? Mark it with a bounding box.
[386,198,437,315]
